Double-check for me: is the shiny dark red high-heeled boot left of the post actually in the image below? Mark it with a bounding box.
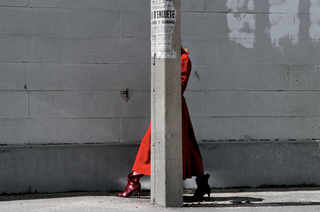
[116,172,143,197]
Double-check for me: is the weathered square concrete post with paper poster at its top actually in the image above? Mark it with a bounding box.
[151,0,183,207]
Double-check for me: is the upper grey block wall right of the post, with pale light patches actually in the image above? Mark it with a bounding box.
[182,0,320,140]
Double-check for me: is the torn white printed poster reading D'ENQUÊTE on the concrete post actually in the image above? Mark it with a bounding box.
[151,0,177,59]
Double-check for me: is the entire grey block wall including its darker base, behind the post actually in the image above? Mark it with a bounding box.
[0,0,320,193]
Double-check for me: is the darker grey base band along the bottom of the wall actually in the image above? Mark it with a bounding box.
[0,141,320,194]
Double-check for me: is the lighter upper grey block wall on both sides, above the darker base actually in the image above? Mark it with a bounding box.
[0,0,320,144]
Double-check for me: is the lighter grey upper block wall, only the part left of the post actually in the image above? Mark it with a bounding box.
[0,0,149,144]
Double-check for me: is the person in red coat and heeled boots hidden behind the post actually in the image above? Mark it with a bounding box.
[117,47,211,200]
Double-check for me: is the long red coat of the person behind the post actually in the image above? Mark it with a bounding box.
[132,51,203,179]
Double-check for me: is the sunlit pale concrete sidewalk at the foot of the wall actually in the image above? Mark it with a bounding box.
[0,190,320,212]
